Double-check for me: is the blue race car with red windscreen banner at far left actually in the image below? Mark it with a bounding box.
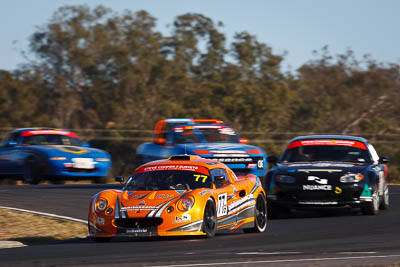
[0,128,111,184]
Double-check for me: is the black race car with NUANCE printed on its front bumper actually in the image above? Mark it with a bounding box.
[264,135,389,215]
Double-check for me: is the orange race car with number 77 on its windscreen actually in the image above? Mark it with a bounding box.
[88,155,267,242]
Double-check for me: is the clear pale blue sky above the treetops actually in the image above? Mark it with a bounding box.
[0,0,400,71]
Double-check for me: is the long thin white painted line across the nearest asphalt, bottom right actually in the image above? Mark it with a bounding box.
[153,254,400,267]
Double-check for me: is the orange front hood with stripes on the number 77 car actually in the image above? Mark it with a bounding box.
[115,190,187,218]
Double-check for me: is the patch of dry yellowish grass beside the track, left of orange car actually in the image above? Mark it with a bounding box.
[0,209,87,244]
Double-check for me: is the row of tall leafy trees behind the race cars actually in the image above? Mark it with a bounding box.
[0,5,400,180]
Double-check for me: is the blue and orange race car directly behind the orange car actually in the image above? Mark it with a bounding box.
[136,119,267,177]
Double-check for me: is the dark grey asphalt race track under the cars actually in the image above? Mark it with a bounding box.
[0,185,400,266]
